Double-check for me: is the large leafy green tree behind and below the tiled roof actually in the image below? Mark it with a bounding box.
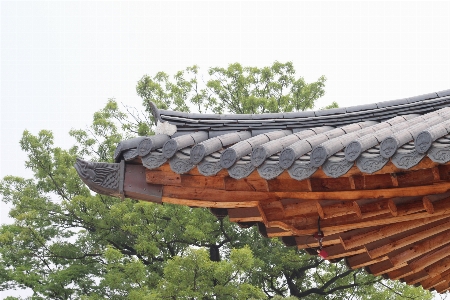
[0,63,431,299]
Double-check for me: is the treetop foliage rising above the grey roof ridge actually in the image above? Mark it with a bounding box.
[136,62,326,114]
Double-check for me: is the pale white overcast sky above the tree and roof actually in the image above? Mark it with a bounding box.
[0,1,450,296]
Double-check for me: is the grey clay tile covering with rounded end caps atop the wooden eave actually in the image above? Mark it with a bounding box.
[115,90,450,180]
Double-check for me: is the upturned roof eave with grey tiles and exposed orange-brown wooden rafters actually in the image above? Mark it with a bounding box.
[75,90,450,293]
